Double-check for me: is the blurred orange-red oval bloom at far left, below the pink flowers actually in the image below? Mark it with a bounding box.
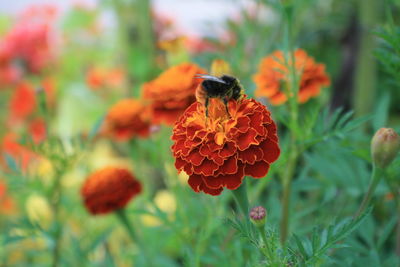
[10,82,36,120]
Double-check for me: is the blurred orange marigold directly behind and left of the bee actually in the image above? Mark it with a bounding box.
[143,63,205,125]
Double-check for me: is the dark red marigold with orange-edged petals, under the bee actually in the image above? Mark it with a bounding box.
[172,98,280,195]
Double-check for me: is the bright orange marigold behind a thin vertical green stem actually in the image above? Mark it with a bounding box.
[253,49,330,105]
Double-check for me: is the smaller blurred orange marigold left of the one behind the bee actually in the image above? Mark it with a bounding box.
[105,99,151,140]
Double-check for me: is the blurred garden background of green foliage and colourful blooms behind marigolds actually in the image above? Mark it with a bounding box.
[0,0,400,267]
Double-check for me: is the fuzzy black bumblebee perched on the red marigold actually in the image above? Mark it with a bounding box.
[195,74,244,117]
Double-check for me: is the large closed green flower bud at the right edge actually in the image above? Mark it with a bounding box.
[371,128,400,168]
